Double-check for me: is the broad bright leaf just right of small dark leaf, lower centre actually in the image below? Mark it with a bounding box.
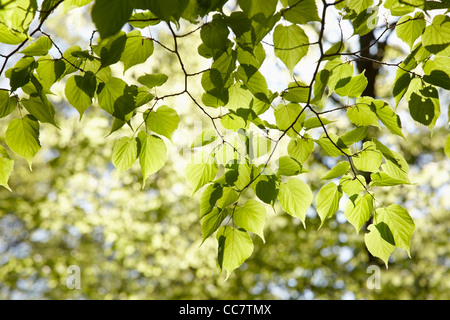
[278,178,313,226]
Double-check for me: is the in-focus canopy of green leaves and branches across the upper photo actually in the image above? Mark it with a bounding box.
[0,0,450,278]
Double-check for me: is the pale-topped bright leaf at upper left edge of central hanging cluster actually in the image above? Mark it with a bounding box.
[186,152,219,195]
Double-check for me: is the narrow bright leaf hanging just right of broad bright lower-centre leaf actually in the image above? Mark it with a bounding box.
[316,182,342,227]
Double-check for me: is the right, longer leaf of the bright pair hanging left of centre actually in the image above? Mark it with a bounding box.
[137,131,167,189]
